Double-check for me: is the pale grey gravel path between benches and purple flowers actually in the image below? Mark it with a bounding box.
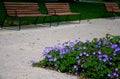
[0,18,120,79]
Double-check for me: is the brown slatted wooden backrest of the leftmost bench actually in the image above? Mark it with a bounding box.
[4,2,40,16]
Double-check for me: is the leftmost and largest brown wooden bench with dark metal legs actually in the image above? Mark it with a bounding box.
[1,2,48,30]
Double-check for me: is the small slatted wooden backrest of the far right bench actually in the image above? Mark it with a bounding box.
[105,3,120,12]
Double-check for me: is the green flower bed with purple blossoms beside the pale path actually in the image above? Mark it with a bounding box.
[32,34,120,79]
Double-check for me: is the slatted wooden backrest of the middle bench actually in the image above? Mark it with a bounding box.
[45,3,71,14]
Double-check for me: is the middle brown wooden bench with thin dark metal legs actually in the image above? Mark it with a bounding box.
[45,3,81,25]
